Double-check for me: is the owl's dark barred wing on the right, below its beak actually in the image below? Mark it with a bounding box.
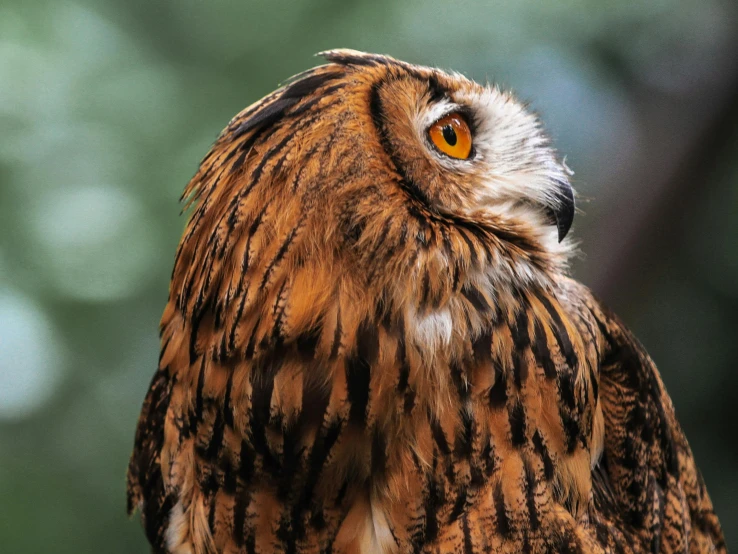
[591,296,726,552]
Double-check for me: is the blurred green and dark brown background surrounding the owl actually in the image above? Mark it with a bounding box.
[0,0,738,553]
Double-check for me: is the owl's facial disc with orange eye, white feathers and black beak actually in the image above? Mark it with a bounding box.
[370,57,574,245]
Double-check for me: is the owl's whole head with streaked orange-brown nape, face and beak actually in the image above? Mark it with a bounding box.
[172,50,574,354]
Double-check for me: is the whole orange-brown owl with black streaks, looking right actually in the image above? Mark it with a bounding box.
[128,50,725,554]
